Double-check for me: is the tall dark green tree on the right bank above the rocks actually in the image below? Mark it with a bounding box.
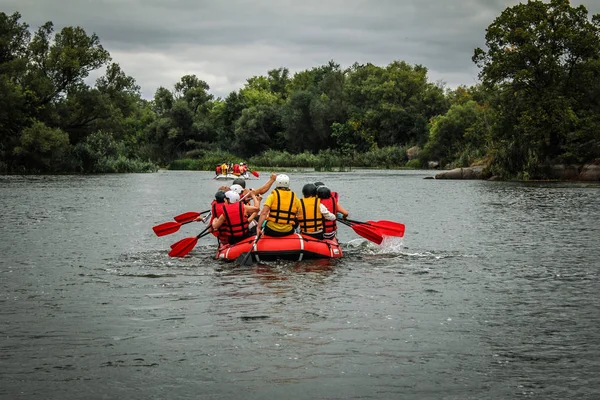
[473,0,600,177]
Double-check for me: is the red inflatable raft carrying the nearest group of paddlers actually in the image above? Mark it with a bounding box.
[217,233,342,262]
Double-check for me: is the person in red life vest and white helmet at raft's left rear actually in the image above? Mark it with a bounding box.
[211,190,259,244]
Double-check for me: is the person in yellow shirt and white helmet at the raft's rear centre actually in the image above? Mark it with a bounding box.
[256,174,304,237]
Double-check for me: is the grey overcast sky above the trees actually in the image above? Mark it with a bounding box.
[0,0,600,98]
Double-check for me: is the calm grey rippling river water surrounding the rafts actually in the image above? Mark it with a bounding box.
[0,170,600,400]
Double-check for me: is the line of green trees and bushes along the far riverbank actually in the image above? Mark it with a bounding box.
[0,0,600,179]
